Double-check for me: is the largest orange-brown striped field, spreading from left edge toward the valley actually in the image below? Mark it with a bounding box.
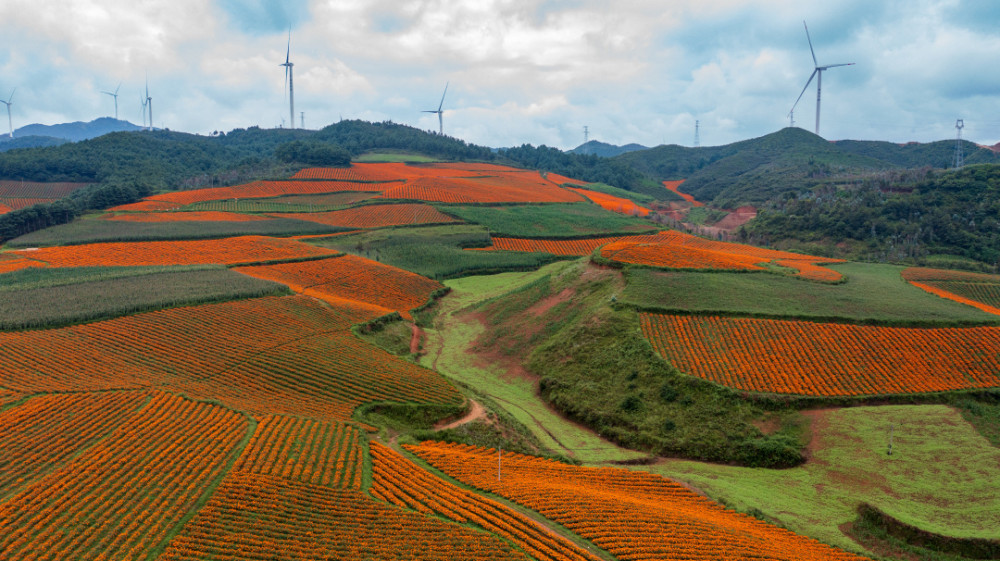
[0,296,461,421]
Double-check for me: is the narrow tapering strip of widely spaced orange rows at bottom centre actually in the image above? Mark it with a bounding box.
[371,442,600,561]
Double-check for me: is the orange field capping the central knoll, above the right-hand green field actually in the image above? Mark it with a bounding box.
[601,231,843,281]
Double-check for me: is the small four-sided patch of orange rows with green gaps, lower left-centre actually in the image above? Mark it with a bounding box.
[233,415,364,490]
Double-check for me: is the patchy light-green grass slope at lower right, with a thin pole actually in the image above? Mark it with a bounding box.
[641,405,1000,549]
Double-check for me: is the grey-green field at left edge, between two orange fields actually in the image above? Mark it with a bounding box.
[0,267,288,330]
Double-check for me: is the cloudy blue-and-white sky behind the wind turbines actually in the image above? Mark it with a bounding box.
[0,0,1000,149]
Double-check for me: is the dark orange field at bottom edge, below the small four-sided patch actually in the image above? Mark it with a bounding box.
[159,472,528,561]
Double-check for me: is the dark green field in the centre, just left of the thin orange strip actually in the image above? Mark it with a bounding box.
[313,224,559,279]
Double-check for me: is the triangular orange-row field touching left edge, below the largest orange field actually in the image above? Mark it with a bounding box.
[0,392,147,498]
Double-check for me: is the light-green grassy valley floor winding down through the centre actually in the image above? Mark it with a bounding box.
[421,263,641,463]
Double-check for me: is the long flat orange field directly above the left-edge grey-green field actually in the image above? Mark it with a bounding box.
[11,236,338,267]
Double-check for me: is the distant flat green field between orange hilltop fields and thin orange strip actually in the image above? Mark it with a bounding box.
[438,203,660,238]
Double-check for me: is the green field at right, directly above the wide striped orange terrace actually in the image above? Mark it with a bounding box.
[620,263,1000,324]
